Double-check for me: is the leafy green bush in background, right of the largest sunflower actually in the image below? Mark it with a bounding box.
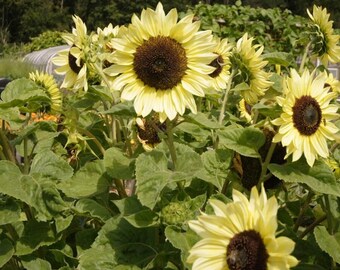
[191,4,307,57]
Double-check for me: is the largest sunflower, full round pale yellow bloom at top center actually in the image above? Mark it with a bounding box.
[106,3,216,122]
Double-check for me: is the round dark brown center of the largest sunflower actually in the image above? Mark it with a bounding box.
[133,36,187,90]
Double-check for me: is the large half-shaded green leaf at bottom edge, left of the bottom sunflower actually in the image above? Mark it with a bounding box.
[79,216,158,270]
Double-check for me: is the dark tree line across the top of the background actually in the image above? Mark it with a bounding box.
[0,0,340,47]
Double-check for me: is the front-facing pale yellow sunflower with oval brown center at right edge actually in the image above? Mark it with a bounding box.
[273,69,338,166]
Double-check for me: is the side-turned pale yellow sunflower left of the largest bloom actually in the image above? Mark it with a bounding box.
[52,16,89,91]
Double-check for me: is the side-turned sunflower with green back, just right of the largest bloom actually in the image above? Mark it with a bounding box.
[232,33,273,105]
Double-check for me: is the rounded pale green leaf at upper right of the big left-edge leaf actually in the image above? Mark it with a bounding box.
[30,150,73,180]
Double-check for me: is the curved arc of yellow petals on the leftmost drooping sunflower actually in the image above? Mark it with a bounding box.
[29,71,62,113]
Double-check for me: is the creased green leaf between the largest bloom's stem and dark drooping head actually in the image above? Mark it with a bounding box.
[199,149,234,190]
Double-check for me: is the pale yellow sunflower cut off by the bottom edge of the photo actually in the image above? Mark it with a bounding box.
[187,187,298,270]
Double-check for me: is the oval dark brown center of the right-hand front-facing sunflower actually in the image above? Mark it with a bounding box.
[293,96,322,136]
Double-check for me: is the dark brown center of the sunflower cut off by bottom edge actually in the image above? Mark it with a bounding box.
[227,230,269,270]
